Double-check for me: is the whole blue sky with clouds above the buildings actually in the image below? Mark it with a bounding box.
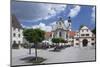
[11,0,96,31]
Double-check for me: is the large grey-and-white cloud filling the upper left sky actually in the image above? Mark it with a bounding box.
[11,1,67,21]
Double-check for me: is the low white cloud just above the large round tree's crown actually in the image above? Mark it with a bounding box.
[32,22,52,32]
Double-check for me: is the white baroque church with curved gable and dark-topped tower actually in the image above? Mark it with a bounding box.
[52,17,71,40]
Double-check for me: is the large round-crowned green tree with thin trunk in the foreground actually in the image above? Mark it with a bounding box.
[23,28,45,61]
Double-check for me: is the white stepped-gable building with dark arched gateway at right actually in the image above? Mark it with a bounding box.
[74,26,96,47]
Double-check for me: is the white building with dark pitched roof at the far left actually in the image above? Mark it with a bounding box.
[11,15,23,48]
